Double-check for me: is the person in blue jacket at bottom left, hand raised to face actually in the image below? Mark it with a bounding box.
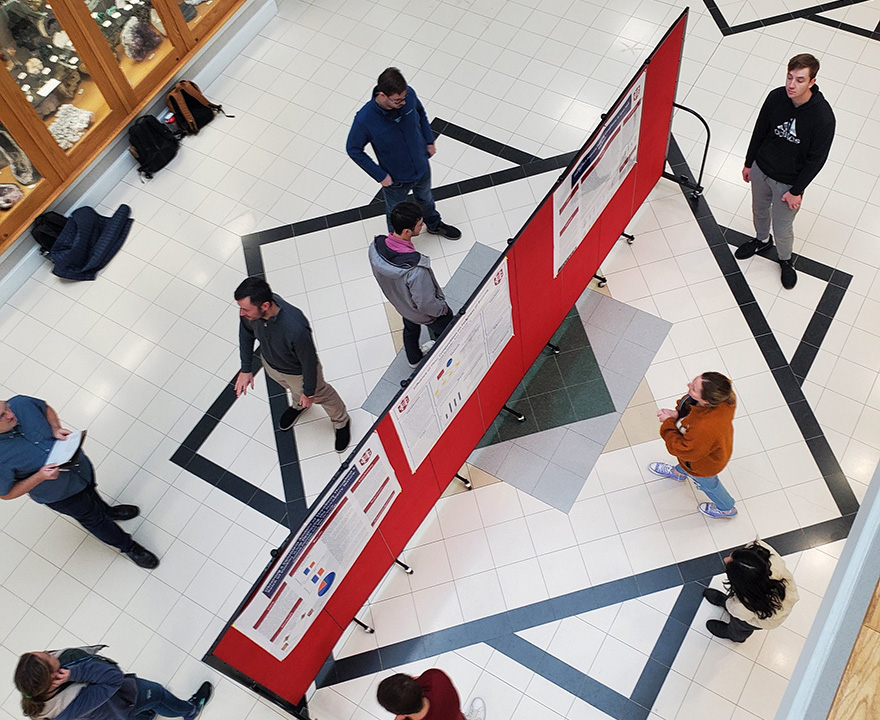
[14,645,214,720]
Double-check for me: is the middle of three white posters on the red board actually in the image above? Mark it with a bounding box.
[391,258,513,472]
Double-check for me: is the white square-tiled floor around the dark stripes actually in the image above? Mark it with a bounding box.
[0,0,880,720]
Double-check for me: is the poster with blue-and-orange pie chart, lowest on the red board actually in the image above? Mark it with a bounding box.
[233,432,400,660]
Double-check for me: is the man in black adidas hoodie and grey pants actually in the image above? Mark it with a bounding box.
[735,53,835,290]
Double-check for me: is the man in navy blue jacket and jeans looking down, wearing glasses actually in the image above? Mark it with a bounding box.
[345,68,461,240]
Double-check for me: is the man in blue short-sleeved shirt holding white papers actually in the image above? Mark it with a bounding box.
[0,395,159,570]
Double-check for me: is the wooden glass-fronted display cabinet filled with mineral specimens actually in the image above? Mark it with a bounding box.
[0,0,245,253]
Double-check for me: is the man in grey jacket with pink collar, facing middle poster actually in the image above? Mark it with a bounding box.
[370,202,453,367]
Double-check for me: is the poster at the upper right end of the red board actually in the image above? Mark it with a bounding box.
[553,72,645,277]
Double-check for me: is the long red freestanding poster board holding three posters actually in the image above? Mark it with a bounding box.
[205,10,687,709]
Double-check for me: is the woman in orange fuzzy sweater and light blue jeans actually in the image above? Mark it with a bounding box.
[648,372,737,518]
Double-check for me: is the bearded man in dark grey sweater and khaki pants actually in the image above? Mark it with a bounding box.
[235,277,351,452]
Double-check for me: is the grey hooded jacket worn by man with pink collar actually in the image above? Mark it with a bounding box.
[369,235,448,325]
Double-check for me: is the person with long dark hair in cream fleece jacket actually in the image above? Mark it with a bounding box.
[703,540,800,642]
